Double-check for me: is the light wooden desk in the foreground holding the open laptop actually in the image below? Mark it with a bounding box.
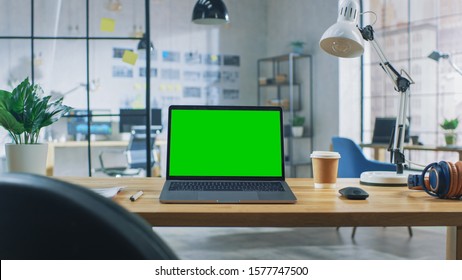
[62,177,462,259]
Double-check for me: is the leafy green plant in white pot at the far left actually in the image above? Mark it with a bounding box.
[0,78,71,175]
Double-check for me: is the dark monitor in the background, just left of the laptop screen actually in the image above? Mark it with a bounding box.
[119,108,162,133]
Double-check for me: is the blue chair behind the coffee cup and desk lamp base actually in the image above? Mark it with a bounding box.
[332,137,413,238]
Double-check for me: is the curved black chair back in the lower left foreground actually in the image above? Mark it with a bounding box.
[0,173,177,260]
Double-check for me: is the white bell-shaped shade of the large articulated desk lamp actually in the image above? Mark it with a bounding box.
[319,0,364,57]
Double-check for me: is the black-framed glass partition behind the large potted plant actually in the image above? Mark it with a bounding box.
[0,0,154,176]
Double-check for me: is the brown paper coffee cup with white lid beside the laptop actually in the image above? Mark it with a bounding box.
[310,151,340,188]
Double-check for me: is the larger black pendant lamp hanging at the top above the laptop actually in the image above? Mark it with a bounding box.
[192,0,229,25]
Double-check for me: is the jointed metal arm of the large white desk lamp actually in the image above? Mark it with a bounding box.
[358,25,414,174]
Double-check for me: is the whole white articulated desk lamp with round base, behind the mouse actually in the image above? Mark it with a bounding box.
[319,0,414,186]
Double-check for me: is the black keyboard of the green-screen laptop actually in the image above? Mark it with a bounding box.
[169,181,285,192]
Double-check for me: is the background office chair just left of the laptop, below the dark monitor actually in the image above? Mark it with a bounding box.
[98,127,158,177]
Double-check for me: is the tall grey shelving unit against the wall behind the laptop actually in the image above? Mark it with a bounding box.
[257,53,313,177]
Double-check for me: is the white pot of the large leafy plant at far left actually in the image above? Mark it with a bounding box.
[5,144,48,175]
